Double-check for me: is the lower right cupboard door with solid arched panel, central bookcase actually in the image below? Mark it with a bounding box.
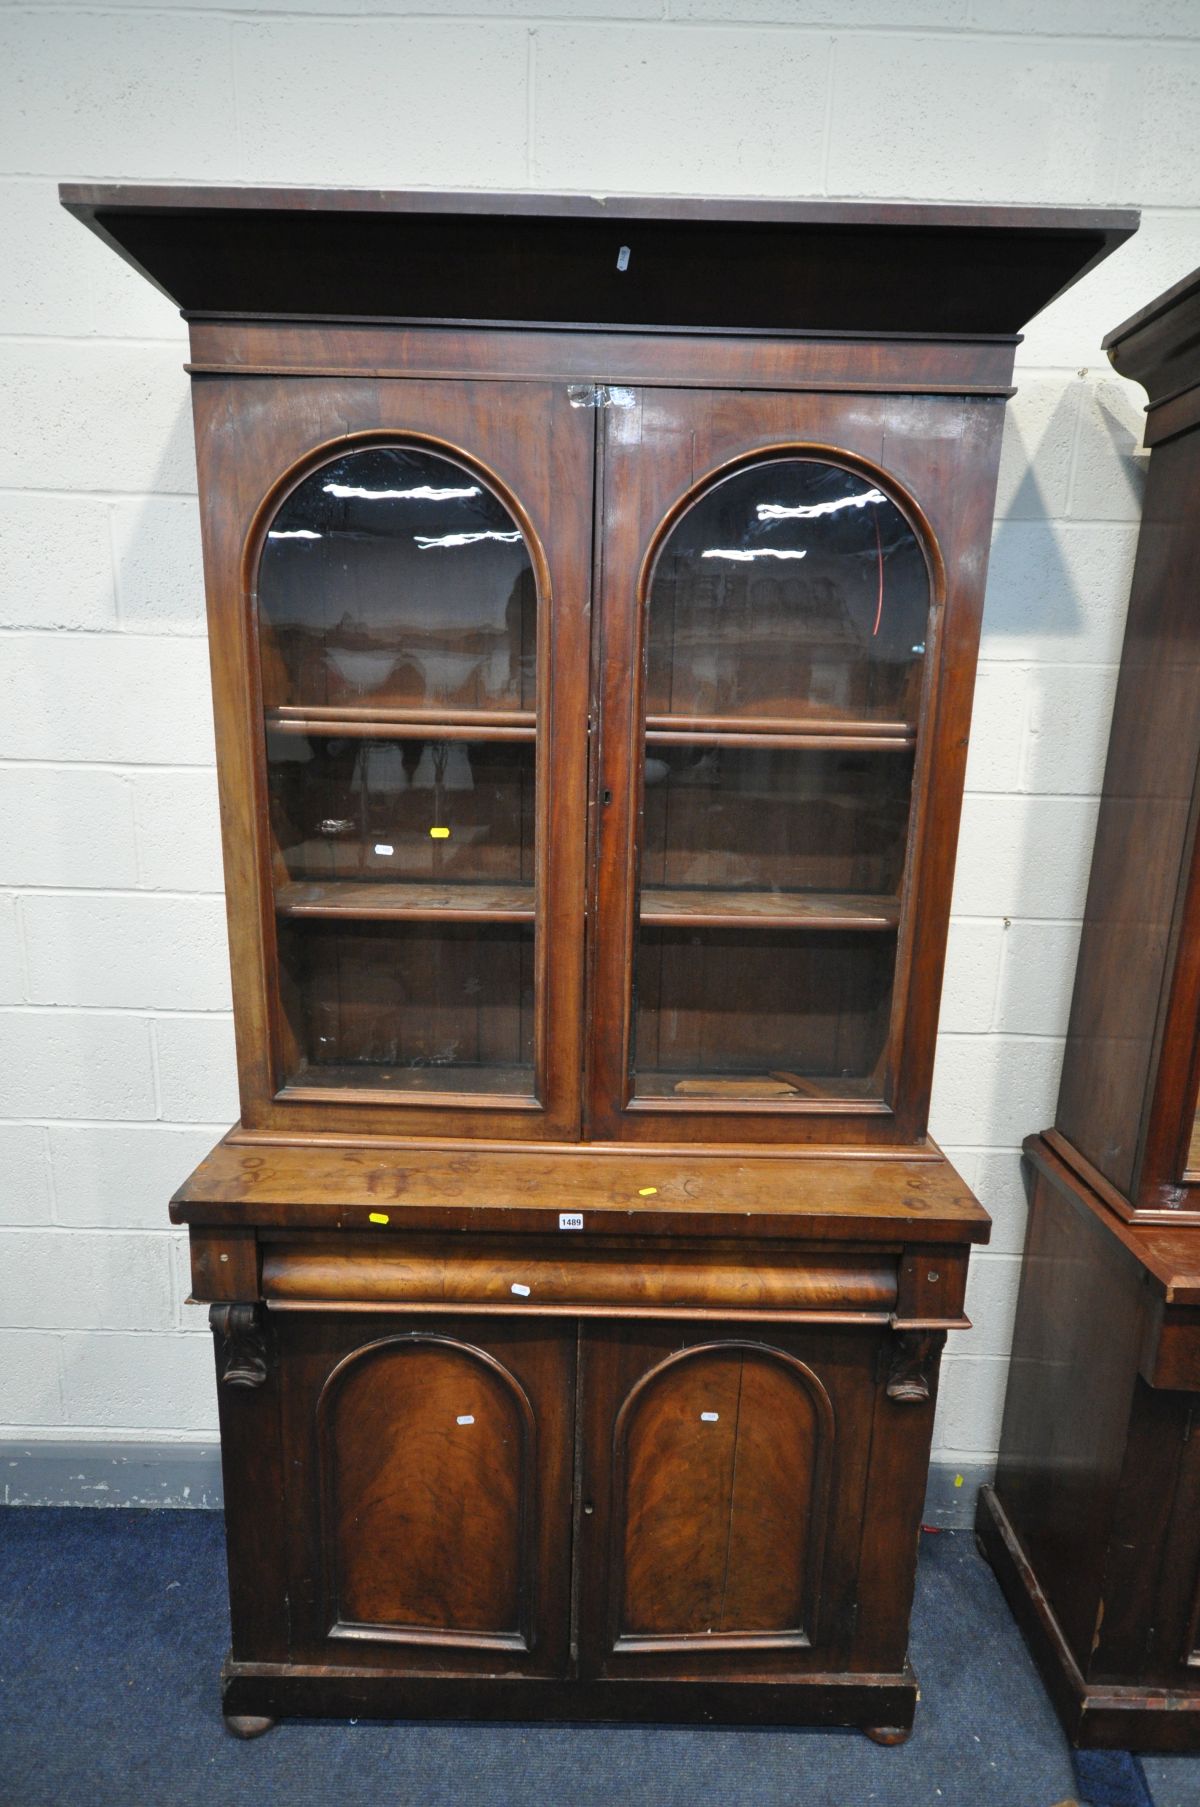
[580,1325,878,1675]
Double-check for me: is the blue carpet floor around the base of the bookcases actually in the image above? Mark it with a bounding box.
[0,1509,1200,1807]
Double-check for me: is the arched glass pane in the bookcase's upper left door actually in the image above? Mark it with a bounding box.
[258,445,539,1100]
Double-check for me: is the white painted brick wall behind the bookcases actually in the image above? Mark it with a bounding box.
[0,0,1200,1464]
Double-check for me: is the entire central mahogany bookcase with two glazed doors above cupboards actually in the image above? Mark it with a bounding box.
[63,186,1135,1742]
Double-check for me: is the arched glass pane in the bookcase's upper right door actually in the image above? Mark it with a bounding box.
[633,454,931,1104]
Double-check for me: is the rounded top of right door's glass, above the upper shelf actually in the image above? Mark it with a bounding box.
[647,457,929,723]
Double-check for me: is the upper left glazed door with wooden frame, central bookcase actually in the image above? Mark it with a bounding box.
[189,379,593,1137]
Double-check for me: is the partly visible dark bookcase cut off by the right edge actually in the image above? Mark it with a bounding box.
[978,271,1200,1751]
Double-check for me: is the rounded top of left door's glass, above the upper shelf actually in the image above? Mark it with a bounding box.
[258,446,537,710]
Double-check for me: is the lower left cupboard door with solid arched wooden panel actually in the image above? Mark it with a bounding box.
[282,1312,575,1675]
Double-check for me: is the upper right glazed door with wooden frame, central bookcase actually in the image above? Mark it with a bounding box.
[589,390,981,1142]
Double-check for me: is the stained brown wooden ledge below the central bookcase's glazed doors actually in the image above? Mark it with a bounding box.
[172,1131,990,1241]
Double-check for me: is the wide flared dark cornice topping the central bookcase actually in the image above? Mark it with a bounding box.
[60,183,1139,336]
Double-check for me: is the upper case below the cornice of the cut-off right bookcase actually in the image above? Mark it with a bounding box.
[1054,432,1200,1211]
